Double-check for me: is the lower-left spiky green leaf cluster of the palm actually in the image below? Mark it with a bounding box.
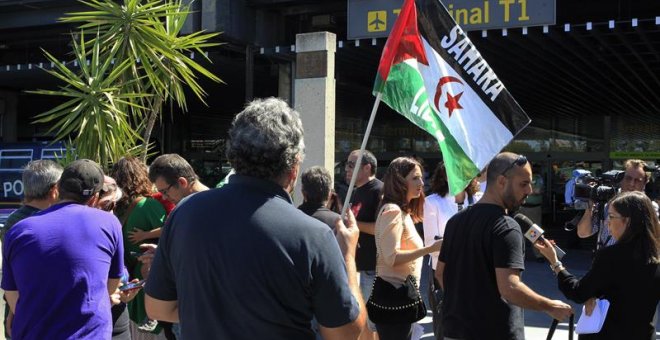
[31,29,149,164]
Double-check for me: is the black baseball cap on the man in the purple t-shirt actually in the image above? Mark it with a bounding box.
[58,159,105,198]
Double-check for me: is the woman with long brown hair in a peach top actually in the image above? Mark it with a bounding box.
[375,157,440,340]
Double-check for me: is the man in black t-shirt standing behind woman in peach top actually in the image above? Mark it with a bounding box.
[345,150,383,339]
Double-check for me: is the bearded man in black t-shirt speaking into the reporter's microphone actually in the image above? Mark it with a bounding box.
[436,152,572,340]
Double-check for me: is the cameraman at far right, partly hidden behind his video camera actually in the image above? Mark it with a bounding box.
[577,159,658,250]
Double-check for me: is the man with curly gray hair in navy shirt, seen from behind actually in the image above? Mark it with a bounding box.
[145,98,366,340]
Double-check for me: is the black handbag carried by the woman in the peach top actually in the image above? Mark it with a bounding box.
[367,275,426,324]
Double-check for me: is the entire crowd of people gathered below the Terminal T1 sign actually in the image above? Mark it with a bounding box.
[2,98,660,340]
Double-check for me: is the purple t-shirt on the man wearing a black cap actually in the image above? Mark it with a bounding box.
[2,203,124,339]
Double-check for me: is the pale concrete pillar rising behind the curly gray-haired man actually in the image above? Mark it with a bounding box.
[293,32,337,204]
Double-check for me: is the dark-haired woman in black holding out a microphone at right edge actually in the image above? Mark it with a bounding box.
[535,191,660,340]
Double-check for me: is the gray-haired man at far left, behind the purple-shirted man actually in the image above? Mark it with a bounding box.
[0,159,62,241]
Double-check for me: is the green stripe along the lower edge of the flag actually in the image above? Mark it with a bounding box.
[374,59,479,195]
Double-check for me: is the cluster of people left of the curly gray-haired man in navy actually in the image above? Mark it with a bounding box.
[1,154,208,339]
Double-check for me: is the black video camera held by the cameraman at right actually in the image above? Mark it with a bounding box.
[574,170,625,202]
